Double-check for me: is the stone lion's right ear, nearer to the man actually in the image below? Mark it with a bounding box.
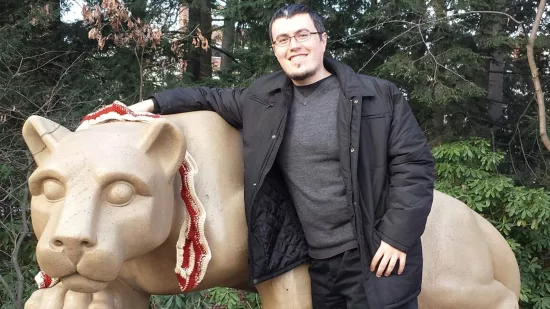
[139,118,186,176]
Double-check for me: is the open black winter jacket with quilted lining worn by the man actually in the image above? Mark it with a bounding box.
[153,58,434,309]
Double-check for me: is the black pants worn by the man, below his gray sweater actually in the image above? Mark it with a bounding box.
[309,249,418,309]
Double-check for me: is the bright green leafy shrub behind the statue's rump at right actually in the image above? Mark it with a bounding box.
[433,138,550,309]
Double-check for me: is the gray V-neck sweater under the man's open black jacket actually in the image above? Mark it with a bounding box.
[277,76,357,259]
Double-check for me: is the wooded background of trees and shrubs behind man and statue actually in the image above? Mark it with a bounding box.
[0,0,550,309]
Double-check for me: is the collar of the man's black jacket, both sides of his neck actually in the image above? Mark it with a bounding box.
[261,57,374,99]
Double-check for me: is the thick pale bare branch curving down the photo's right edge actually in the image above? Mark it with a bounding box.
[527,0,550,150]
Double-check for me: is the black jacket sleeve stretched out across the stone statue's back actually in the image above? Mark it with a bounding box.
[152,87,246,129]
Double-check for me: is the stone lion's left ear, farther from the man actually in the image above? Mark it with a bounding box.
[23,115,71,165]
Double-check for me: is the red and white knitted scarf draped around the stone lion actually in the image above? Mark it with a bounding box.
[35,101,212,292]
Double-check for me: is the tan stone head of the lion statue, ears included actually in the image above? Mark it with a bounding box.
[23,116,186,293]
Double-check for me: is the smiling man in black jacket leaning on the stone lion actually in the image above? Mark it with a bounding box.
[131,4,434,309]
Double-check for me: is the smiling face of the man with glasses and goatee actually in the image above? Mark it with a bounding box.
[271,14,327,85]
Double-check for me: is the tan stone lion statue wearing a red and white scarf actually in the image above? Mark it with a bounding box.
[23,104,520,309]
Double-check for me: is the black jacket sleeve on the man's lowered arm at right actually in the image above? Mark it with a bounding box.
[378,84,435,253]
